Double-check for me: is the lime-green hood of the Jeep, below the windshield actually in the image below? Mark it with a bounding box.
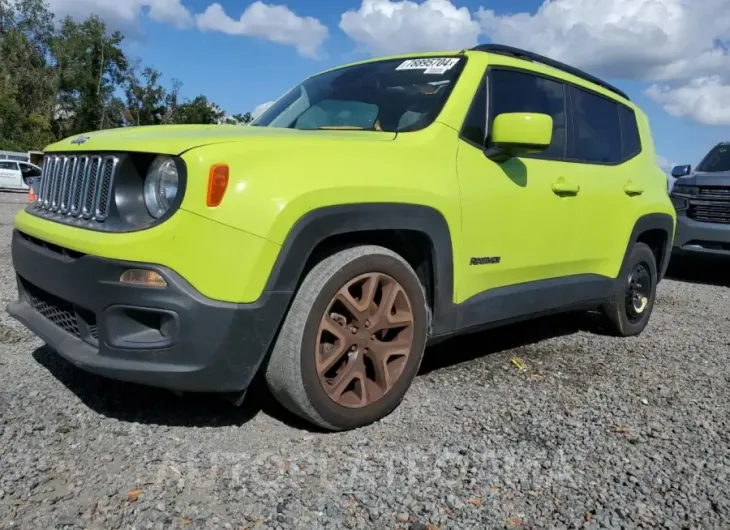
[45,125,396,155]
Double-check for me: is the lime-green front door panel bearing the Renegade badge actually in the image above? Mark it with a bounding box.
[457,142,584,302]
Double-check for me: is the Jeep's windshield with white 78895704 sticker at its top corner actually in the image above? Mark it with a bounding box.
[251,57,466,132]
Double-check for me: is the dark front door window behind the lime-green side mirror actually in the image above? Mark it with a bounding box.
[489,69,567,159]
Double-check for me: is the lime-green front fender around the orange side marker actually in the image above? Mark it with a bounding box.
[176,123,463,304]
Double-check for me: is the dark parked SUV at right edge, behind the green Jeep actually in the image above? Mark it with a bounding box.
[671,142,730,256]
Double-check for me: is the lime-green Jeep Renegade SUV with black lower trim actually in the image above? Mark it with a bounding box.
[9,45,675,430]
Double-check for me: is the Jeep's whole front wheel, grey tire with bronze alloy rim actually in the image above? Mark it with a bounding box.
[265,245,429,430]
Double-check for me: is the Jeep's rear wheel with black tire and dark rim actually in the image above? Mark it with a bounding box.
[601,243,658,337]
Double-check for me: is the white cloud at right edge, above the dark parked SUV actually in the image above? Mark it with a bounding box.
[646,76,730,125]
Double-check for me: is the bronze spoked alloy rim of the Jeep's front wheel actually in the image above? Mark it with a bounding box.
[315,272,414,408]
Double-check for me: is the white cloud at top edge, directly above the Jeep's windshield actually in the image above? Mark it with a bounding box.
[340,0,479,55]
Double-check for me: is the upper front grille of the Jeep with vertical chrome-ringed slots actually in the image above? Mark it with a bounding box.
[35,155,119,222]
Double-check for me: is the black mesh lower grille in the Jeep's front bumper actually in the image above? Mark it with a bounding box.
[20,278,99,345]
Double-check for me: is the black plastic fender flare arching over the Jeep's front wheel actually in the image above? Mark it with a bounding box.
[264,203,455,332]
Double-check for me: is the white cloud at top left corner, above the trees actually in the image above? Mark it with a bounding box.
[48,0,192,32]
